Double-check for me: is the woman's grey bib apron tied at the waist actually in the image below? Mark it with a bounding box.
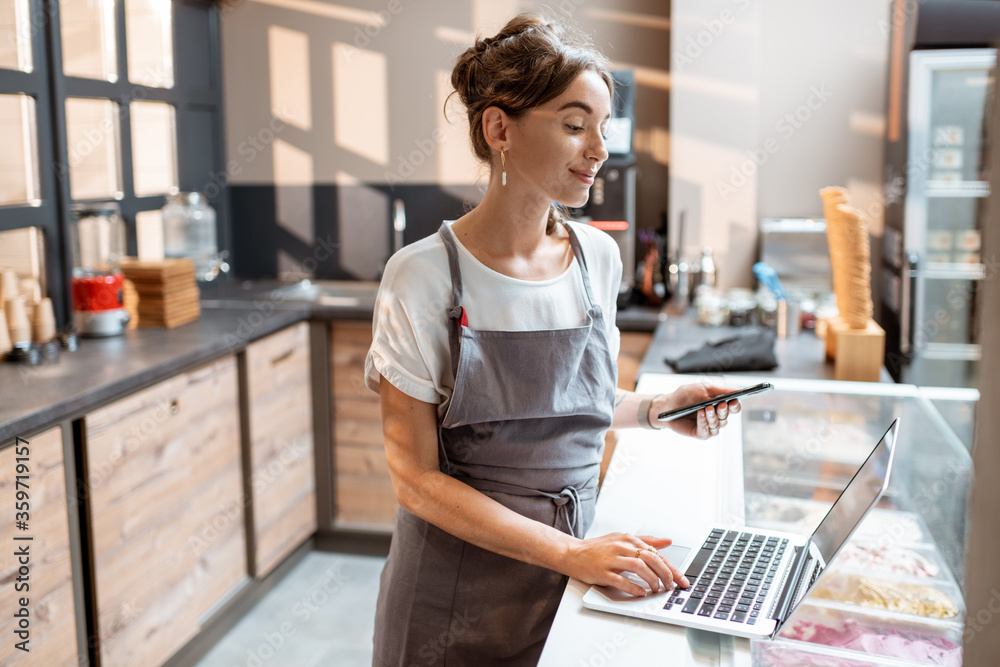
[374,225,617,667]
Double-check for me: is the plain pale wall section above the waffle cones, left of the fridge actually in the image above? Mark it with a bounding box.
[670,0,889,287]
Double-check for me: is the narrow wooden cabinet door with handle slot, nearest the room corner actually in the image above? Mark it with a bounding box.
[246,322,316,578]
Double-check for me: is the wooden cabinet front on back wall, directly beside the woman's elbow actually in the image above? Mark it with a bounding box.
[330,321,399,531]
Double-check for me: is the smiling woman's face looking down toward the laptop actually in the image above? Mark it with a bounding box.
[507,69,611,207]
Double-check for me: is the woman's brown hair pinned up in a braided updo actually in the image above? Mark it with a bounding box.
[451,14,614,232]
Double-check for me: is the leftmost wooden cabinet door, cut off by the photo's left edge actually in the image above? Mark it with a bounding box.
[0,426,78,666]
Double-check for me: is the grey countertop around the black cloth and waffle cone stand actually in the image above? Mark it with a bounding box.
[638,312,892,382]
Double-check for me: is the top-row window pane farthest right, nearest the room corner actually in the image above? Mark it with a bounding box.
[125,0,174,88]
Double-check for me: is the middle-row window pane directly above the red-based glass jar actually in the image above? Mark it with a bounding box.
[66,97,122,200]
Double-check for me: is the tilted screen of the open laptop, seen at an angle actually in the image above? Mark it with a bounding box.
[812,420,899,563]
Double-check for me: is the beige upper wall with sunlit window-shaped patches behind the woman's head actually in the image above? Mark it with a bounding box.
[222,0,669,225]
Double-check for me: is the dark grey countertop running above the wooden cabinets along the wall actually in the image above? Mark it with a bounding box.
[0,279,672,443]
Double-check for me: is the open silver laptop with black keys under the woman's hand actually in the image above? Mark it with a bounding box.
[583,419,899,639]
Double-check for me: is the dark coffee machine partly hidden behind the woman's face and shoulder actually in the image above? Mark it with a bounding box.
[570,70,636,307]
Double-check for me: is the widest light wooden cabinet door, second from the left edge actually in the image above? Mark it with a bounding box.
[84,357,247,667]
